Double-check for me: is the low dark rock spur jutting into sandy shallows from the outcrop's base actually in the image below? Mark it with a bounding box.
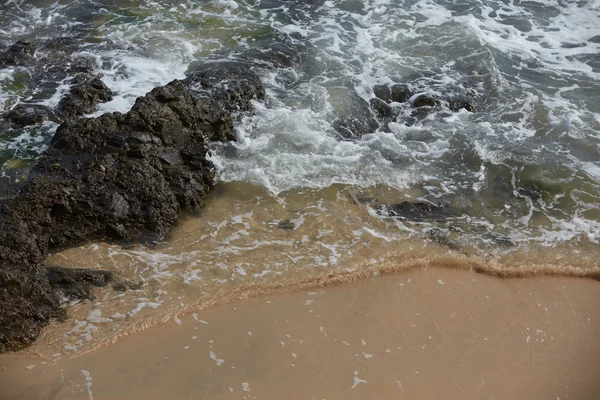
[46,267,113,300]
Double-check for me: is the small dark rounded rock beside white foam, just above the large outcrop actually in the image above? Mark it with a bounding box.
[58,78,112,120]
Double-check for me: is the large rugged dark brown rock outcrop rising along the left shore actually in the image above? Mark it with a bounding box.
[0,62,265,352]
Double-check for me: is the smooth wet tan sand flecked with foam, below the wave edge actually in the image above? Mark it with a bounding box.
[0,268,600,399]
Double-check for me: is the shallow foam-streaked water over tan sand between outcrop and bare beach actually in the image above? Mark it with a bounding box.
[15,184,600,359]
